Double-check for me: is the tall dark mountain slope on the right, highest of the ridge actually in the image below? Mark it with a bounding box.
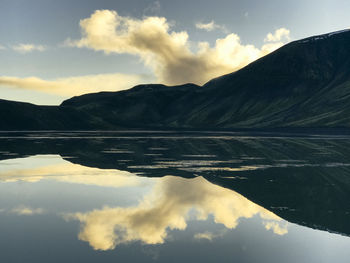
[197,28,350,127]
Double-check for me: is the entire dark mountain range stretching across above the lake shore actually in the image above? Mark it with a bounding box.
[0,30,350,129]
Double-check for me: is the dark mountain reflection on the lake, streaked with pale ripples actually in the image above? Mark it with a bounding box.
[0,133,350,235]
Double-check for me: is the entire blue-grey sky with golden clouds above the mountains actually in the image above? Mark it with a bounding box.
[0,0,350,105]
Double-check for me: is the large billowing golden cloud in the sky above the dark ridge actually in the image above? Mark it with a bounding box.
[66,10,290,85]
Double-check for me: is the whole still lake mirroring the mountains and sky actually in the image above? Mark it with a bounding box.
[0,131,350,262]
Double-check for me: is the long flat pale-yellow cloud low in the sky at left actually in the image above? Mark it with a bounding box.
[0,73,151,96]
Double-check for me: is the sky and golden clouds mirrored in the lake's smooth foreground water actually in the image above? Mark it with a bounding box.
[0,156,349,262]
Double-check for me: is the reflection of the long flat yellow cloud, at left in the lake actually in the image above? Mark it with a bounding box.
[0,155,140,187]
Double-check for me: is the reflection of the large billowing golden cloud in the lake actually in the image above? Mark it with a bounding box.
[66,176,287,250]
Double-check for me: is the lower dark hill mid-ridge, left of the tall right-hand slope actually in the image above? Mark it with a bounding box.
[61,84,200,128]
